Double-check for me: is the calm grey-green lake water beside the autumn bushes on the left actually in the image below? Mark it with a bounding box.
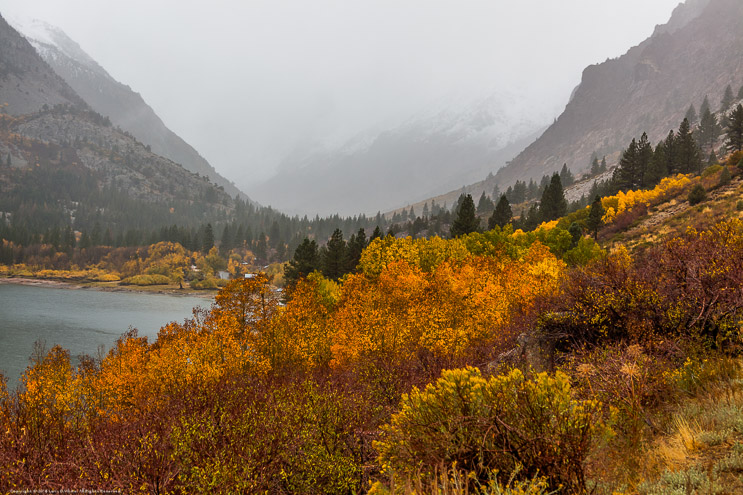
[0,284,214,389]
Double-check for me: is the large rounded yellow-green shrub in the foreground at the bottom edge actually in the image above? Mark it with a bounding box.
[375,367,610,493]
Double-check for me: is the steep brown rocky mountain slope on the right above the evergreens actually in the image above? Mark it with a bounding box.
[486,0,743,189]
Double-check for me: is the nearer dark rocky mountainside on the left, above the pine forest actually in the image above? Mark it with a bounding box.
[0,12,234,232]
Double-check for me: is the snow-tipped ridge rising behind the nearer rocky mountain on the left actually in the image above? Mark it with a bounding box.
[10,18,247,202]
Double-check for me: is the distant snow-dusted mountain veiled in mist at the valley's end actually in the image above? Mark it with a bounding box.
[248,93,553,215]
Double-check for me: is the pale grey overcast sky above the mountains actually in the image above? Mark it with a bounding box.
[0,0,678,186]
